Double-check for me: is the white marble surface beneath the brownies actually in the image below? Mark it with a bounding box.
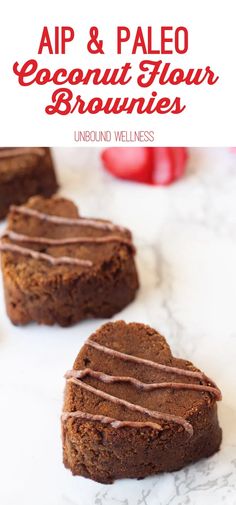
[0,149,236,505]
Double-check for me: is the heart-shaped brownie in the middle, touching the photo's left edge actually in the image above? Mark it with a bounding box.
[0,196,138,326]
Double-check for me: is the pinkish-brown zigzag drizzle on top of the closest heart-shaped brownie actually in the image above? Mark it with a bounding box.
[62,339,221,436]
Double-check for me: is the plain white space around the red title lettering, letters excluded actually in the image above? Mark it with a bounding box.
[0,0,236,146]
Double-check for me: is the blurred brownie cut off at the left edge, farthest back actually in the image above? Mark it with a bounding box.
[0,147,58,219]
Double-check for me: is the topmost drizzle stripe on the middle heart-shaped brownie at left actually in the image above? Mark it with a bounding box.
[10,205,128,233]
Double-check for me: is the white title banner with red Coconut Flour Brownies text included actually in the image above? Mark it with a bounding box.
[0,0,236,146]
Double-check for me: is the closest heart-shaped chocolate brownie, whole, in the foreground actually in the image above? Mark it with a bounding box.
[62,321,222,483]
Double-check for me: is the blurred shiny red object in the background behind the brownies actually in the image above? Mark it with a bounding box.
[101,147,188,186]
